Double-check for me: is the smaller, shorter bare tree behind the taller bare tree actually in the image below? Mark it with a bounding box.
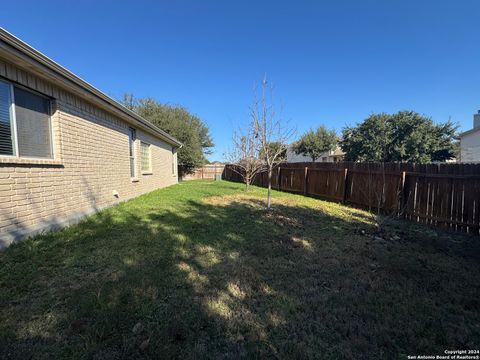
[224,122,266,191]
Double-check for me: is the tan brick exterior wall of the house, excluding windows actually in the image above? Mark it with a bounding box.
[0,59,178,248]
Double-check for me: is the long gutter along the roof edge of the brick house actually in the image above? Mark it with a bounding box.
[0,27,183,148]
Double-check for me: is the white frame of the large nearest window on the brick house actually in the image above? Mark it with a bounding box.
[0,78,55,160]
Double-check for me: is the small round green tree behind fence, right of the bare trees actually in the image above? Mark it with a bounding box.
[293,125,338,162]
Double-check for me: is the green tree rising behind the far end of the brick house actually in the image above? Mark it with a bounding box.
[120,94,214,173]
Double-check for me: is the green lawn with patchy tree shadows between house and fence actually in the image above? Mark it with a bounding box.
[0,181,480,359]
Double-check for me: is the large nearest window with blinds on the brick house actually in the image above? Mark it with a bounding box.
[0,81,53,158]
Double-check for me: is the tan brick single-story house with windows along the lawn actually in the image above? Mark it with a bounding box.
[0,29,181,248]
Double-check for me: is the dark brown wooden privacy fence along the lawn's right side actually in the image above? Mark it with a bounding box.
[223,162,480,235]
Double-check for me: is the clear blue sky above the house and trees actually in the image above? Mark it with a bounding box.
[0,0,480,160]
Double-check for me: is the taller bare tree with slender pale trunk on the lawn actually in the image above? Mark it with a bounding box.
[250,77,295,209]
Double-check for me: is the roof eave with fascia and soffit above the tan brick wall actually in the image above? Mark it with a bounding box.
[0,27,182,147]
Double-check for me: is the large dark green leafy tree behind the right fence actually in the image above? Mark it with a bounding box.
[340,111,457,163]
